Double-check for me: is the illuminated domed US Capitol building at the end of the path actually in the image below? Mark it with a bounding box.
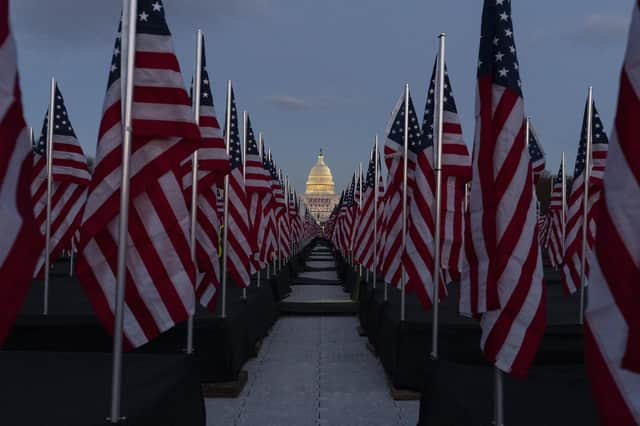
[304,150,340,223]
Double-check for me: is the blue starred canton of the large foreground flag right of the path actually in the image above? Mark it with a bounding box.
[478,0,522,96]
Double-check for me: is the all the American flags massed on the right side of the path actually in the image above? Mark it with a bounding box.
[325,0,640,425]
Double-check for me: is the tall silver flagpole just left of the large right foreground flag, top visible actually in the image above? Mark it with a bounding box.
[431,33,446,359]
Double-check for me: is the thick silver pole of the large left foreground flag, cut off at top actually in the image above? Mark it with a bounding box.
[107,0,138,424]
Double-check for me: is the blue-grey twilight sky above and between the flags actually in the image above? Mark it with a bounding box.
[11,0,633,191]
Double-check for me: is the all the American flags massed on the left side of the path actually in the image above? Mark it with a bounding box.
[0,0,320,349]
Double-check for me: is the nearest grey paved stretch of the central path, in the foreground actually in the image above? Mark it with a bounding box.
[205,317,418,426]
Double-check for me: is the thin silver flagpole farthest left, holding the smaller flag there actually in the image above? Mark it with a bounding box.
[42,77,56,315]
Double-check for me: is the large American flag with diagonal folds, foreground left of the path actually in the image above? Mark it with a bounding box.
[77,0,200,349]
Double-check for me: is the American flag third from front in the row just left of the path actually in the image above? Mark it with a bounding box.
[224,88,256,288]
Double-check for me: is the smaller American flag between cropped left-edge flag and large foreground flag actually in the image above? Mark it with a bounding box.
[31,84,91,277]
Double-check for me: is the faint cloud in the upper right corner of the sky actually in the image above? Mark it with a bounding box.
[569,13,629,47]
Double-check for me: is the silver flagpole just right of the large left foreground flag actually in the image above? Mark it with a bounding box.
[186,30,203,354]
